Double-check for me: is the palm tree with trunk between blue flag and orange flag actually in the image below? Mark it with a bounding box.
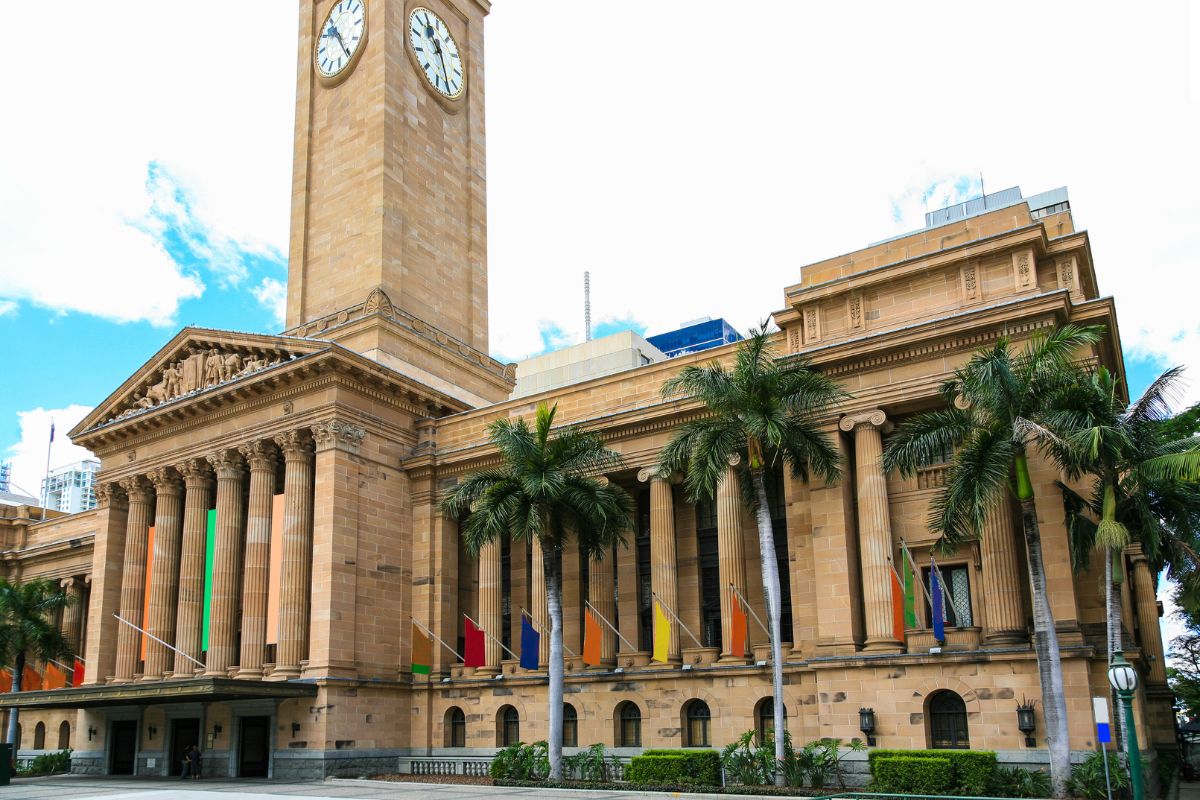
[442,404,634,780]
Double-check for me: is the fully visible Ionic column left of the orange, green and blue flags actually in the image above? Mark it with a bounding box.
[839,409,904,652]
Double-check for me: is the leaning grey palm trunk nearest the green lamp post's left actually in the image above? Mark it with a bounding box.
[1015,455,1070,798]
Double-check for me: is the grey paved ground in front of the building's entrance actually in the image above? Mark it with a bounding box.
[0,775,782,800]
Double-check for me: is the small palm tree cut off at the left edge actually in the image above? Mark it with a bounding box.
[0,578,71,757]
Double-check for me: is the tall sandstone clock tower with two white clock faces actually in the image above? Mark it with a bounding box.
[286,0,512,407]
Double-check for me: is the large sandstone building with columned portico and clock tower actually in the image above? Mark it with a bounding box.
[0,0,1175,777]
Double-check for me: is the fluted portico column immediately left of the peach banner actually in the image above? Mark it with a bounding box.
[238,440,275,678]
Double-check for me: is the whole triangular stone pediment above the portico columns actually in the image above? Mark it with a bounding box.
[70,327,331,437]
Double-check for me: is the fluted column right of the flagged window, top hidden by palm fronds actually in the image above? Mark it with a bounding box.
[979,489,1028,644]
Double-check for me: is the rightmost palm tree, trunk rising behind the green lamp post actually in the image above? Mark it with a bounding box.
[1045,367,1200,753]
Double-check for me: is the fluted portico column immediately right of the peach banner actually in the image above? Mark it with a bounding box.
[271,431,313,678]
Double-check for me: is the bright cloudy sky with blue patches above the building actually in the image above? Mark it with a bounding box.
[0,0,1200,638]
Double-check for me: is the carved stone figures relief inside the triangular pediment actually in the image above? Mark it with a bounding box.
[106,345,295,421]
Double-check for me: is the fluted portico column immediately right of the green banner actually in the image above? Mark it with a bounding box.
[205,450,246,676]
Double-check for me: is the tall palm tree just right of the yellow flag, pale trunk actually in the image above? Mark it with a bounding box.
[659,324,848,786]
